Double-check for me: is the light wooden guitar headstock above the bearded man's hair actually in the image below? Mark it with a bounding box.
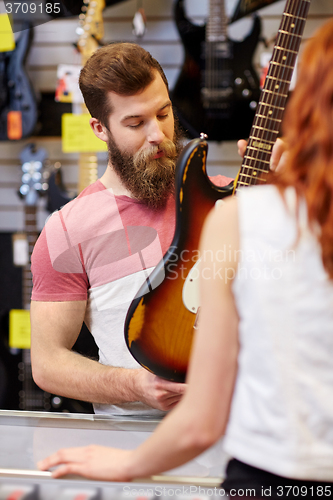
[76,0,105,65]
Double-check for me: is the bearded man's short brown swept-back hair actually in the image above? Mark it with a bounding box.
[79,43,169,127]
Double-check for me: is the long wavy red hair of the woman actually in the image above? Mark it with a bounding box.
[274,19,333,278]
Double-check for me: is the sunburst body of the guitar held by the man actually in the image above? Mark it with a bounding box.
[125,139,233,382]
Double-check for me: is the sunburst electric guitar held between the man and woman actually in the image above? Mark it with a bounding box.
[125,0,310,382]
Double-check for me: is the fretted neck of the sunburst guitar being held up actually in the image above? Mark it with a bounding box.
[235,0,310,191]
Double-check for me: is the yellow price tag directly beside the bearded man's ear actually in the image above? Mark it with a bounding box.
[61,113,107,153]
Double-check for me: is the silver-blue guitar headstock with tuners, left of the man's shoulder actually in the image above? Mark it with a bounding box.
[19,144,49,206]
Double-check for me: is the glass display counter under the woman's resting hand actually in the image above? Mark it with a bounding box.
[0,410,227,500]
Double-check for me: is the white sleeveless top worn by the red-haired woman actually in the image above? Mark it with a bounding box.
[225,186,333,481]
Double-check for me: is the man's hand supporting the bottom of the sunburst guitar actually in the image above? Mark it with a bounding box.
[135,368,186,411]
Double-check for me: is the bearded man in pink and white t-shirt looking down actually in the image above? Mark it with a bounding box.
[31,43,230,416]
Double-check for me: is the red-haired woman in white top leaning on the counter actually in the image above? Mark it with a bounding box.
[39,19,333,499]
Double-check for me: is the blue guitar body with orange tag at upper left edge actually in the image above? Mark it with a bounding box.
[0,23,37,141]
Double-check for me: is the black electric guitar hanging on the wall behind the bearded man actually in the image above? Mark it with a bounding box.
[172,0,261,141]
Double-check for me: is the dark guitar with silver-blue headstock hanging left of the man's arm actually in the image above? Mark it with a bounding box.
[0,144,92,413]
